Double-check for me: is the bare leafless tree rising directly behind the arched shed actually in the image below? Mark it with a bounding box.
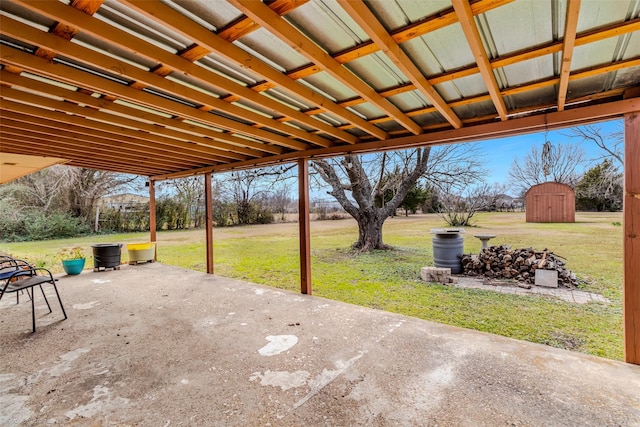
[509,143,585,194]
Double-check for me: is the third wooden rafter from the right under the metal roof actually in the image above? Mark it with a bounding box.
[338,0,462,129]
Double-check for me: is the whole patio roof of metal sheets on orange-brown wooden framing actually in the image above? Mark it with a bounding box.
[0,0,640,179]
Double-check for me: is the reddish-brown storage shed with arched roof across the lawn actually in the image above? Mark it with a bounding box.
[525,182,576,222]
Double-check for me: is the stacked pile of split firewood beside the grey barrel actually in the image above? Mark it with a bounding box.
[461,245,578,288]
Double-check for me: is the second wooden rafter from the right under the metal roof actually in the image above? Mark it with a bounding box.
[452,0,507,120]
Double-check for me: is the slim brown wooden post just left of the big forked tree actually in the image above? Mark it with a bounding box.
[298,159,312,295]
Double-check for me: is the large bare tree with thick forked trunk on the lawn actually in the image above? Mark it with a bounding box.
[313,144,482,251]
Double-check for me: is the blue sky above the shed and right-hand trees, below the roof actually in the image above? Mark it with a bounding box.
[474,119,622,184]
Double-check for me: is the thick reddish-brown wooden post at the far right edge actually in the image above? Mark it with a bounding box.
[623,111,640,365]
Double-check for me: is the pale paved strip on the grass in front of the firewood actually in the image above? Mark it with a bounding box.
[454,276,610,304]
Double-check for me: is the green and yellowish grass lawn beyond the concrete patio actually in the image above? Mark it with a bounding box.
[0,212,623,360]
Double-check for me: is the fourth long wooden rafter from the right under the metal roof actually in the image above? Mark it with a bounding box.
[229,0,422,135]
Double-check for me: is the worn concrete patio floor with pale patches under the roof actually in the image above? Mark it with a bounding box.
[0,264,640,427]
